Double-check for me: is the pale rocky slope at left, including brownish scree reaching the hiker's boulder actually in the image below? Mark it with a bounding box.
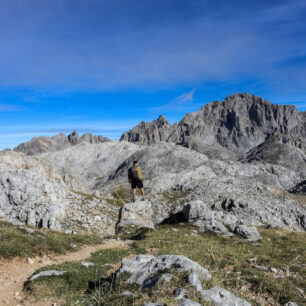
[0,151,118,236]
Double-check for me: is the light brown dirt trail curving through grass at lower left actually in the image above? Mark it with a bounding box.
[0,239,128,306]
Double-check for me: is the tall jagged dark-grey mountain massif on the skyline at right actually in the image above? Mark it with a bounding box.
[121,93,306,158]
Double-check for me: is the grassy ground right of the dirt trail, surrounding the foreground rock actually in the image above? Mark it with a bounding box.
[24,225,306,305]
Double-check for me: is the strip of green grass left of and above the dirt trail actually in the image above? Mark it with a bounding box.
[0,221,102,258]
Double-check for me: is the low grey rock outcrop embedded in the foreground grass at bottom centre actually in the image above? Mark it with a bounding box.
[116,255,250,306]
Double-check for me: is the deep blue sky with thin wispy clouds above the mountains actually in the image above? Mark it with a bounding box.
[0,0,306,149]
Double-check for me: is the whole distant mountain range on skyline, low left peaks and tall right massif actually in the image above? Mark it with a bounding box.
[14,93,306,173]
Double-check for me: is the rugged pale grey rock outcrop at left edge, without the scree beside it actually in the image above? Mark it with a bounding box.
[0,155,73,230]
